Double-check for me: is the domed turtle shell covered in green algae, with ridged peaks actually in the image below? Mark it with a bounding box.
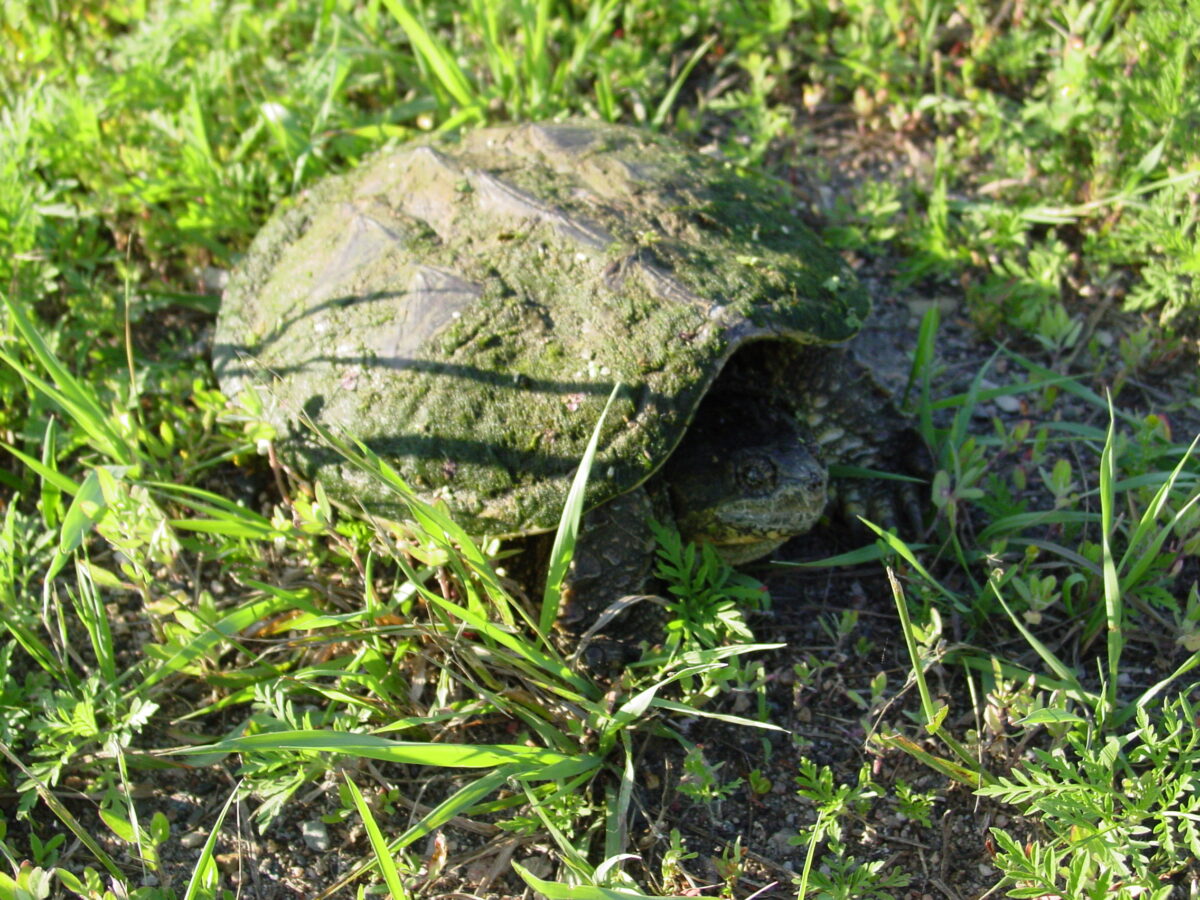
[214,121,869,536]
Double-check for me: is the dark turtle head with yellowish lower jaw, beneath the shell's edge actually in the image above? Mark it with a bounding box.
[665,395,828,564]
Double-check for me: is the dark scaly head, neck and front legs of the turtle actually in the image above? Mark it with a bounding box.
[558,342,919,671]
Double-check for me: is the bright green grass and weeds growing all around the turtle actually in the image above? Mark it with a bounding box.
[0,0,1200,900]
